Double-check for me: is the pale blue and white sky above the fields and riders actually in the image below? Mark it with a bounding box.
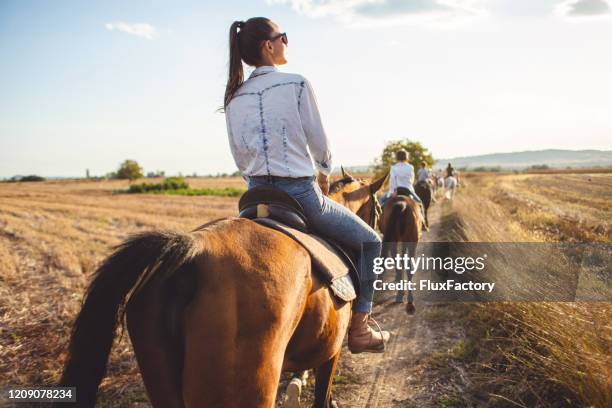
[0,0,612,178]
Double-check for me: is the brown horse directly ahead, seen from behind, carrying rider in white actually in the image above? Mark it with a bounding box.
[380,195,424,314]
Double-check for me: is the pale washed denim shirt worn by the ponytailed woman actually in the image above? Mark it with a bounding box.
[225,66,332,177]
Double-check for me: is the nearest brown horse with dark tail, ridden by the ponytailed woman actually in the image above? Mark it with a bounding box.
[60,172,384,408]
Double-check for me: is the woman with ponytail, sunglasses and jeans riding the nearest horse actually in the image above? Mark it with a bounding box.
[224,17,389,353]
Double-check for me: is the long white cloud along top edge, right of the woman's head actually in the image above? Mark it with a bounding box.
[266,0,487,27]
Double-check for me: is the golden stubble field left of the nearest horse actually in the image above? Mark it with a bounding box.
[0,178,244,406]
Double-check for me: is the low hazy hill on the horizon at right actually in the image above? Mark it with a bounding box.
[435,149,612,170]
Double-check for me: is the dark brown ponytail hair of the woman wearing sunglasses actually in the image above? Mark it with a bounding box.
[223,17,274,109]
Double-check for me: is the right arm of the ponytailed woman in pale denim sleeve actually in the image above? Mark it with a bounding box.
[298,78,333,175]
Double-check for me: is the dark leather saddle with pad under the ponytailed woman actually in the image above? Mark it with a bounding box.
[238,187,359,302]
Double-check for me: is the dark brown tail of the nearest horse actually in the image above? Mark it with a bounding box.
[59,231,198,407]
